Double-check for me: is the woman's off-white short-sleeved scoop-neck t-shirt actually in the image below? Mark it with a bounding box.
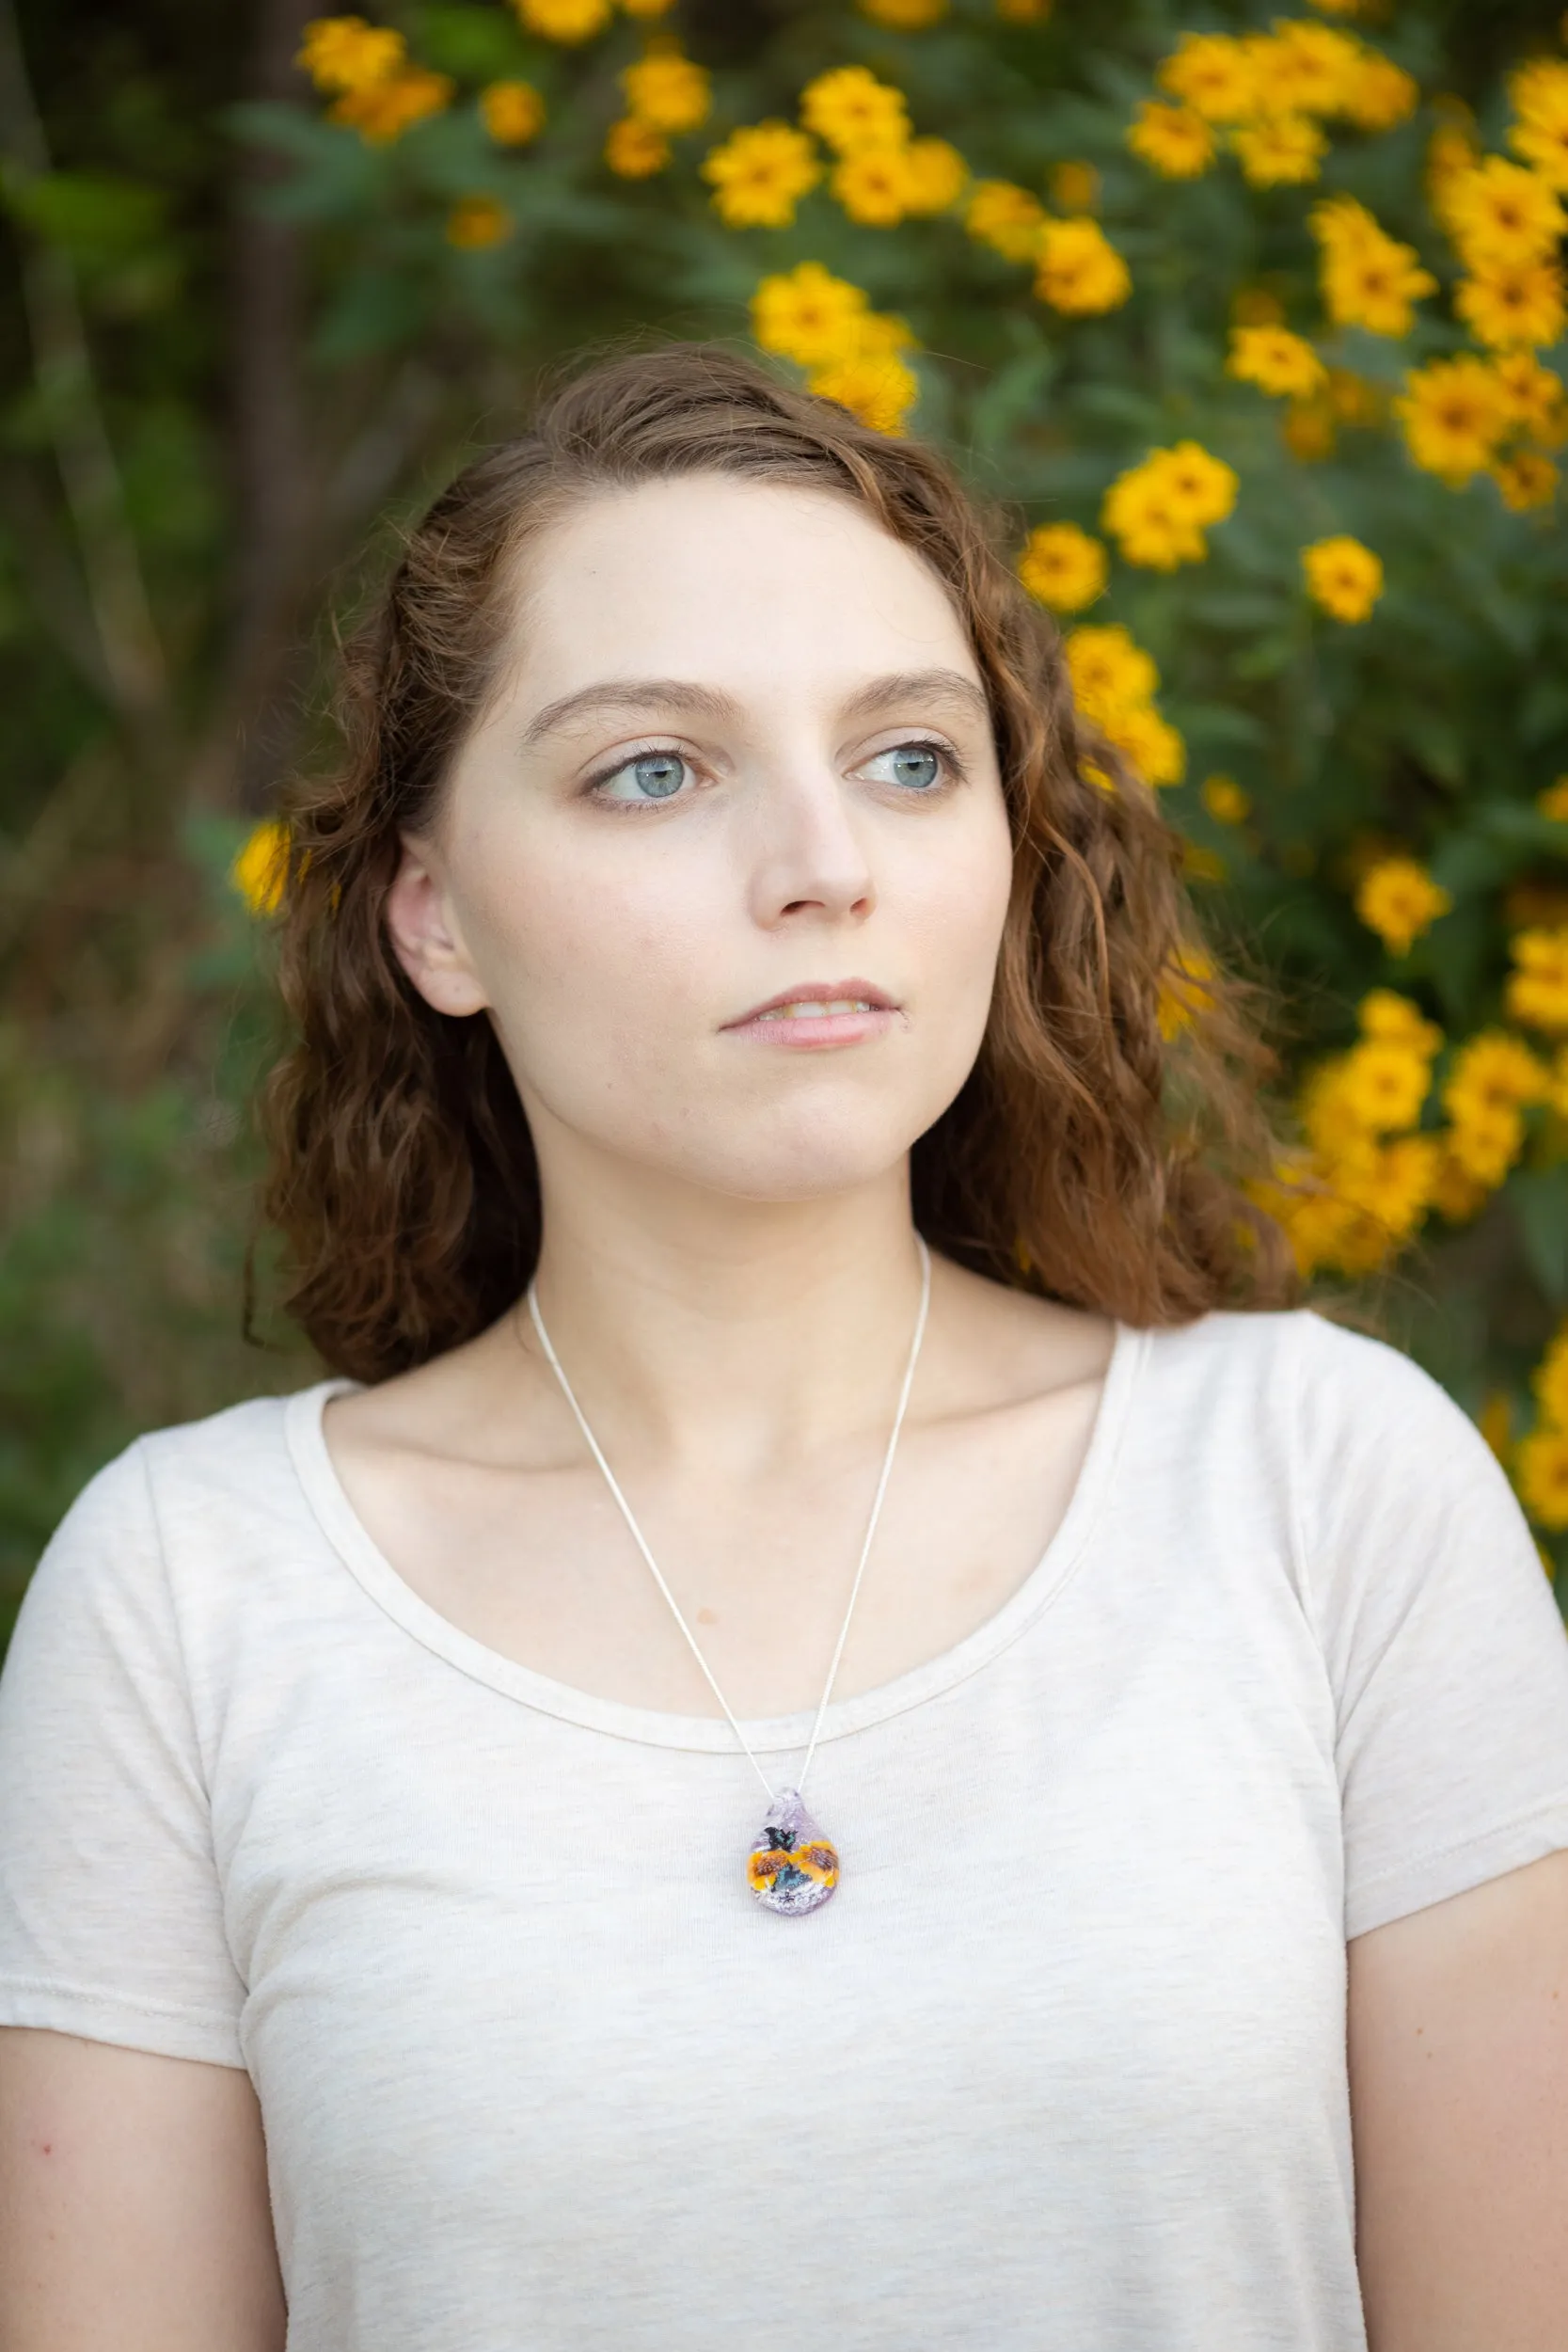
[0,1312,1568,2352]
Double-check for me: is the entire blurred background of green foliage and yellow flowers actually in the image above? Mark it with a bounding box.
[0,0,1568,1637]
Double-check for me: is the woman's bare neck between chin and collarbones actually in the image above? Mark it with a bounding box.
[513,1120,922,1475]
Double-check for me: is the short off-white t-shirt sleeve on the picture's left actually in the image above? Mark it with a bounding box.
[0,1444,245,2065]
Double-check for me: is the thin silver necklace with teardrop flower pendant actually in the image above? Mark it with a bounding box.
[527,1232,931,1919]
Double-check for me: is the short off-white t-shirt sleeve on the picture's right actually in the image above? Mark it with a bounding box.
[1295,1315,1568,1938]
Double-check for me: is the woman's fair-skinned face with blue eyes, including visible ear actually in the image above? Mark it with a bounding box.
[388,475,1011,1200]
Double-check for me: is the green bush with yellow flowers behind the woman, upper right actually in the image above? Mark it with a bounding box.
[249,0,1568,1590]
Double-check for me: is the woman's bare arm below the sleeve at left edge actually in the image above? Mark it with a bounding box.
[0,2026,284,2352]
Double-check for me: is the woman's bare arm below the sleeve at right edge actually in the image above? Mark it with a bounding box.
[1350,1853,1568,2352]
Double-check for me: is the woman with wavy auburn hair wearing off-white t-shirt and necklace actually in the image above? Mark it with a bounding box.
[0,351,1568,2352]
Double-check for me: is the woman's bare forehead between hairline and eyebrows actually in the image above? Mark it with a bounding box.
[517,475,980,696]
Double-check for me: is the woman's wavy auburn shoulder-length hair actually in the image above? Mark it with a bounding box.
[261,343,1295,1383]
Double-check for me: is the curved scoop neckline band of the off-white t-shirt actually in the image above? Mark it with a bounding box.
[284,1320,1149,1755]
